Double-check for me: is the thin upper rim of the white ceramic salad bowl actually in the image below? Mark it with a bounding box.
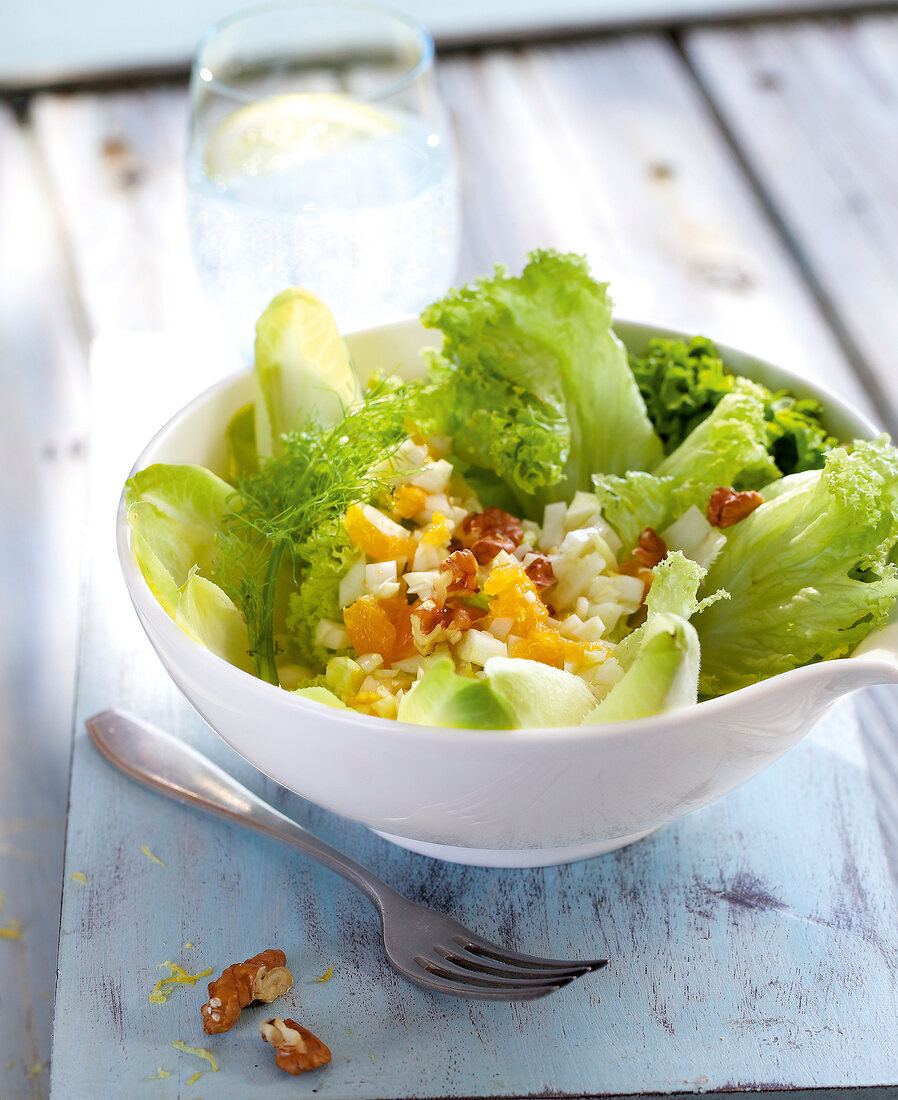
[116,317,880,751]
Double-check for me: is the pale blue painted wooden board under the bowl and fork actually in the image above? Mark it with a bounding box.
[52,338,898,1100]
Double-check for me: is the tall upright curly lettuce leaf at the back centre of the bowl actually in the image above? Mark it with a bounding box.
[421,251,662,517]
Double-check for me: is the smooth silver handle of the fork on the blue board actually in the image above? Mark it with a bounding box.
[85,707,401,917]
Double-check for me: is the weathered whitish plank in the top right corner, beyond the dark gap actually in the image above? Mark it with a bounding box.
[685,14,898,431]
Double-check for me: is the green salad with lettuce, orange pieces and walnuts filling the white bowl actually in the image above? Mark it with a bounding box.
[125,251,898,729]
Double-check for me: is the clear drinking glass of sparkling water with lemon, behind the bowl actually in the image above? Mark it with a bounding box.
[187,0,459,348]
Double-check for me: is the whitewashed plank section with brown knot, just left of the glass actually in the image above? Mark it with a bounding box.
[32,85,207,334]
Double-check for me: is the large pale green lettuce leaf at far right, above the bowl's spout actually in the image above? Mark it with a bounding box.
[696,437,898,695]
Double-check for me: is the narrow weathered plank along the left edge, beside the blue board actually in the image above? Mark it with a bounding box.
[0,105,86,1100]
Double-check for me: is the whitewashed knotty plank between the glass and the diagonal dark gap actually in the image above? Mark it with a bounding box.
[442,36,869,420]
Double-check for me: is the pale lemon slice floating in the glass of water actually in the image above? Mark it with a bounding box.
[206,94,398,184]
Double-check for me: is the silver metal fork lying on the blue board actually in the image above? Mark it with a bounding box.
[86,710,607,1001]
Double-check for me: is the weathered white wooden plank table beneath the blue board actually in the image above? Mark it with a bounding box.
[0,14,898,1100]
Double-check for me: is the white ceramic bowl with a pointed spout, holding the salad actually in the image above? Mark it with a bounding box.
[118,321,898,867]
